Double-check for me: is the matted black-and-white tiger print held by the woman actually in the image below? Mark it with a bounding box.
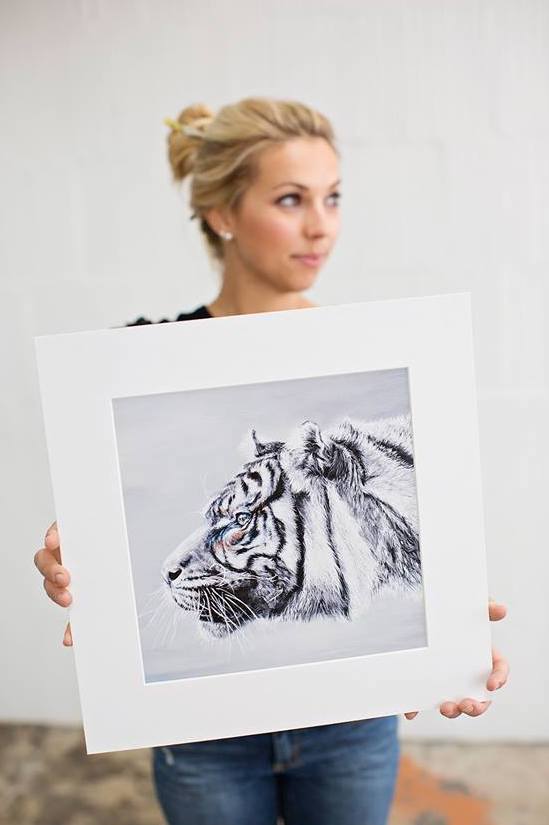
[35,293,491,753]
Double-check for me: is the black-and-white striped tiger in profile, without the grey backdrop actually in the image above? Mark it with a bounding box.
[161,415,421,637]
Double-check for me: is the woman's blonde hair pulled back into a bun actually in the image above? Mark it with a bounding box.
[166,97,339,262]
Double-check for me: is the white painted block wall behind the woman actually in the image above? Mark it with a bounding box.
[0,0,549,740]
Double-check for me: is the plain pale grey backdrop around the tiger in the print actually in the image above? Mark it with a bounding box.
[113,369,426,681]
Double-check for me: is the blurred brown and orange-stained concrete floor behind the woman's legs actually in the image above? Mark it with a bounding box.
[0,724,549,825]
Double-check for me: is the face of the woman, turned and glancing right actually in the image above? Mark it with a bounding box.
[212,138,340,291]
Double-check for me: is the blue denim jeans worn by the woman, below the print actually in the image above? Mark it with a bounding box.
[153,716,399,825]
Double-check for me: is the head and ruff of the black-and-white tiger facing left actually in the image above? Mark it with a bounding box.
[158,421,382,637]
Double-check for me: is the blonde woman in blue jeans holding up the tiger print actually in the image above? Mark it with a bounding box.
[35,98,508,825]
